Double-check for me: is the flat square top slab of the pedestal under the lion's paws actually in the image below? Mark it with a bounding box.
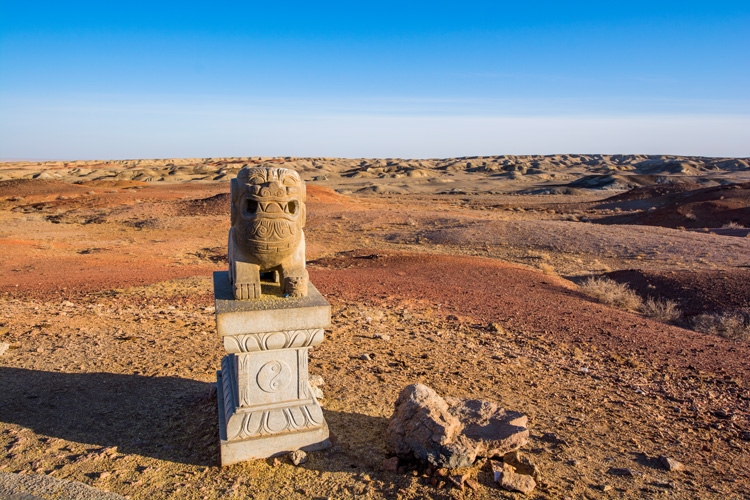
[214,271,331,336]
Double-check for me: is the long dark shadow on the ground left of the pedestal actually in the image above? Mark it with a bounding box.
[0,367,219,465]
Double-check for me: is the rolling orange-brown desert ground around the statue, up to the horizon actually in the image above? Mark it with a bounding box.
[0,155,750,499]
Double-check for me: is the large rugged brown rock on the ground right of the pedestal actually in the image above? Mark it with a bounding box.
[386,384,528,469]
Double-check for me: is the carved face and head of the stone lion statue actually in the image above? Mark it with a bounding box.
[232,166,305,253]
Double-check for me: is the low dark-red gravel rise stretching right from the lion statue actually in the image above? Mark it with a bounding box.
[310,253,750,383]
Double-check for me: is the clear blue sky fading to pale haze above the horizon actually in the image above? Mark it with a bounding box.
[0,0,750,159]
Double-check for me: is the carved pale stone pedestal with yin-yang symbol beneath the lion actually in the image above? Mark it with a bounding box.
[214,272,331,465]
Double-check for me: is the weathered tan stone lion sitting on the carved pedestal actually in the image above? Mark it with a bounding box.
[229,165,308,300]
